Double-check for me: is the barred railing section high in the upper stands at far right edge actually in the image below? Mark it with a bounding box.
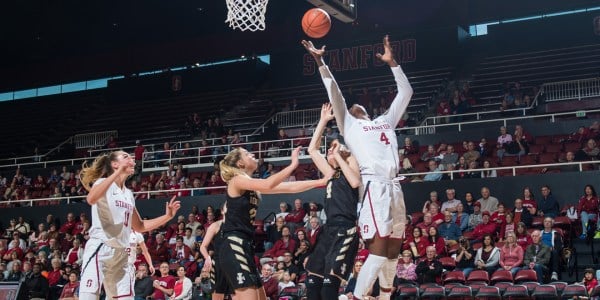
[541,78,600,102]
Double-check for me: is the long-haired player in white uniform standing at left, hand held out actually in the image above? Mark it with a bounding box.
[79,151,181,300]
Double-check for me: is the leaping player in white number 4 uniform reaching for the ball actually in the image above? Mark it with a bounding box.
[302,36,413,299]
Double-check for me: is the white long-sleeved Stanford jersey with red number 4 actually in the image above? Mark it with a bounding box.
[319,65,413,179]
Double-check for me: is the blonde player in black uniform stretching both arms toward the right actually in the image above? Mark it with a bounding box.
[215,147,333,300]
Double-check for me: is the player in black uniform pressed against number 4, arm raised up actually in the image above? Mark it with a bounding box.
[306,103,360,300]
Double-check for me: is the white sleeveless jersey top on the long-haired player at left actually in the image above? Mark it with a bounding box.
[90,178,135,248]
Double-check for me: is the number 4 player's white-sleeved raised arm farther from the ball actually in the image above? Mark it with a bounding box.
[376,35,413,126]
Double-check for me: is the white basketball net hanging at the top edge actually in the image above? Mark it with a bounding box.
[225,0,269,31]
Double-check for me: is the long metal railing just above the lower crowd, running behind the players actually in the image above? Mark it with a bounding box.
[0,160,600,206]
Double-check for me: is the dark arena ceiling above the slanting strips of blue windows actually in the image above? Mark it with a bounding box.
[0,0,598,92]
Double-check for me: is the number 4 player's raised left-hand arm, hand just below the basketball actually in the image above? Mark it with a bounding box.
[302,40,350,135]
